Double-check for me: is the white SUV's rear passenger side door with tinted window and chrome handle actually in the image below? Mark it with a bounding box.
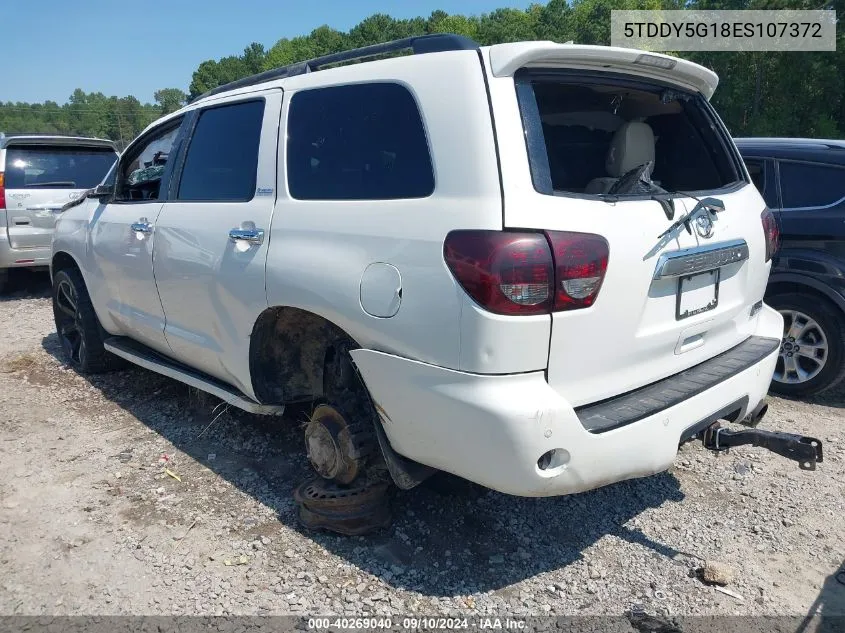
[154,89,282,394]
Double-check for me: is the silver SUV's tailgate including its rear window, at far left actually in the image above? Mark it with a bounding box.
[5,140,117,249]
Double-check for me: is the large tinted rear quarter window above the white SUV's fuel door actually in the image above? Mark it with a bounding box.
[287,83,434,200]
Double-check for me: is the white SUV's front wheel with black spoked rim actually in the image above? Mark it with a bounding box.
[53,269,122,374]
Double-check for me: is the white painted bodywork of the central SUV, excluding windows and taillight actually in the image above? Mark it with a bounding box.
[53,42,782,496]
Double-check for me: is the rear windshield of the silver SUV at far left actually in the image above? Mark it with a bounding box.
[6,145,117,189]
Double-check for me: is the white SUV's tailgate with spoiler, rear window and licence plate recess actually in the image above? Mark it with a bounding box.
[490,45,770,406]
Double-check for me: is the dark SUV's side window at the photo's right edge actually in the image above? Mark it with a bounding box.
[780,161,845,209]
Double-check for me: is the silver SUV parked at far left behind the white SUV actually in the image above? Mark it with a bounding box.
[0,134,117,292]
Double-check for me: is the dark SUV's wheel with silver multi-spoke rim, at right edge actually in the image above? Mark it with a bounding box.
[766,292,845,397]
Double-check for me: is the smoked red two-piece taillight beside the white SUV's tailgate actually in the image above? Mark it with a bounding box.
[443,230,608,315]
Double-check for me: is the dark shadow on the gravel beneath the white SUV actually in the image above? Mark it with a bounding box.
[43,334,684,600]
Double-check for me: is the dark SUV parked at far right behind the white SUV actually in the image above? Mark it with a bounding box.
[734,138,845,396]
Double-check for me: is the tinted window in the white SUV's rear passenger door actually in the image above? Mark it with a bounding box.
[176,100,264,200]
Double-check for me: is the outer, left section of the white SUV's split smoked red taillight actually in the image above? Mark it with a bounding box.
[443,231,554,314]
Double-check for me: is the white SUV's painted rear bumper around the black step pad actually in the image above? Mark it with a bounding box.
[352,306,783,497]
